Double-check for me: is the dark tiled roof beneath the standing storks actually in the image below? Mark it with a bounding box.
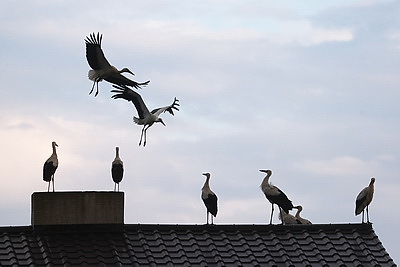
[0,224,396,267]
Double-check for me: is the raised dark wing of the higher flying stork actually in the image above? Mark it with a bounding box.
[85,33,111,70]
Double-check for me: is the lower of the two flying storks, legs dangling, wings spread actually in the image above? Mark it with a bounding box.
[111,85,179,146]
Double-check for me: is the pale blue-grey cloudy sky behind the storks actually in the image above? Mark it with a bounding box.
[0,0,400,263]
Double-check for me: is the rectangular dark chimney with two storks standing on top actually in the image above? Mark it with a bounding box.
[31,191,124,226]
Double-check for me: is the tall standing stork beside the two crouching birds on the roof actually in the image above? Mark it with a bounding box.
[260,170,293,224]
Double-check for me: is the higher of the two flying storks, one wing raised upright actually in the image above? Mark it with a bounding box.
[85,33,150,96]
